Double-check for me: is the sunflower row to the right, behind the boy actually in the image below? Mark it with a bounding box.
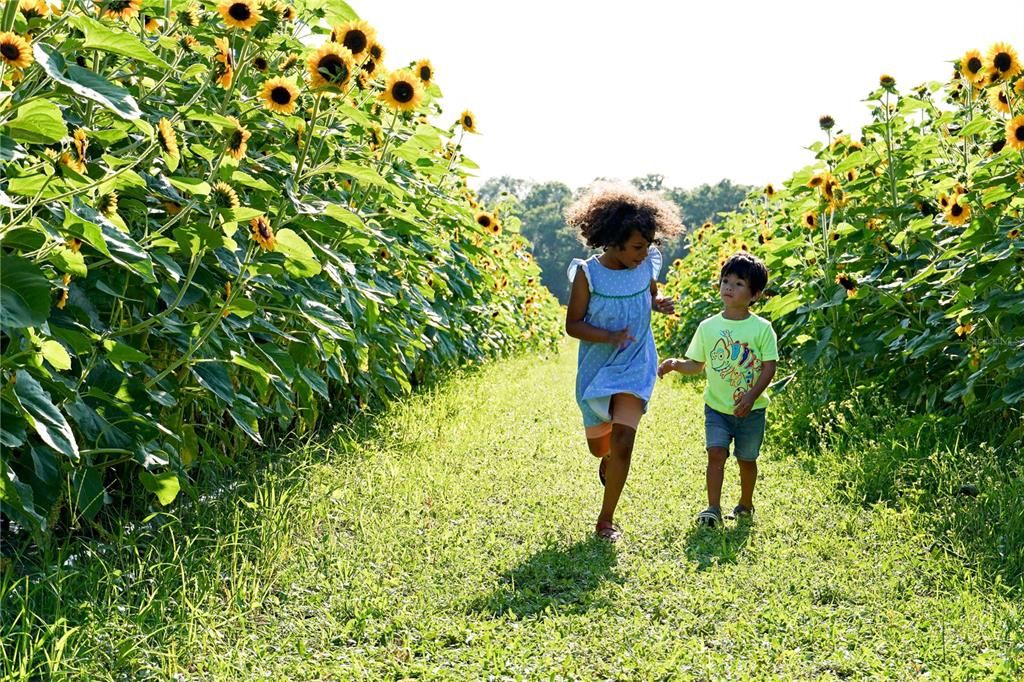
[657,43,1024,419]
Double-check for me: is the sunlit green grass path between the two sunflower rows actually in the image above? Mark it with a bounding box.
[6,344,1024,680]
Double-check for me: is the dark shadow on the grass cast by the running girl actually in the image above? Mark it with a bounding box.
[469,538,622,617]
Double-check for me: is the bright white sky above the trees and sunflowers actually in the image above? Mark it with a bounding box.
[360,0,1024,187]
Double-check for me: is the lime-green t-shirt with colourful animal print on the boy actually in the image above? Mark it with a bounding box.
[686,312,778,415]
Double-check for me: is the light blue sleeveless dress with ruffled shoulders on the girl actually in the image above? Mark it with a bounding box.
[567,246,662,427]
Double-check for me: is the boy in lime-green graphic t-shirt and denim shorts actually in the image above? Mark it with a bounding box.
[657,252,778,526]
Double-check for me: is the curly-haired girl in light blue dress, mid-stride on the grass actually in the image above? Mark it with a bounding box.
[565,185,682,542]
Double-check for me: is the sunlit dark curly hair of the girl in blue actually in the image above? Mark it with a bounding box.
[565,183,684,249]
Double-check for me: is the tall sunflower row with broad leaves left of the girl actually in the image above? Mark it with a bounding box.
[0,0,560,538]
